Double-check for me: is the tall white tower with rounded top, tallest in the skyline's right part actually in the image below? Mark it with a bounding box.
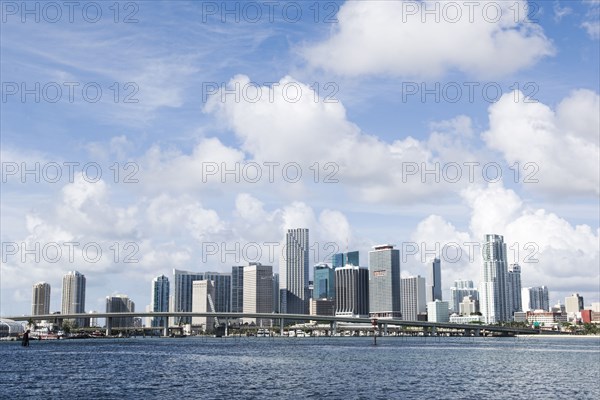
[479,235,512,324]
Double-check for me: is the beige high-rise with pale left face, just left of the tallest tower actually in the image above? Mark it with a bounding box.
[243,263,273,327]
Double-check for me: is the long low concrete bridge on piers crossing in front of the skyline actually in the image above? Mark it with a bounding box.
[2,312,540,336]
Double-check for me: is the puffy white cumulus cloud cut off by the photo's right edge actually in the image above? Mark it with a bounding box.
[482,89,600,195]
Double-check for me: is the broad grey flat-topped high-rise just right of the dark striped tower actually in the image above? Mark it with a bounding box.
[369,244,402,318]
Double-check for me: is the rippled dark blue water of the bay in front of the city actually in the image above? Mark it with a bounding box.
[0,337,600,399]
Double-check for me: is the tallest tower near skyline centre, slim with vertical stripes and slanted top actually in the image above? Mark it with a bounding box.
[279,228,310,314]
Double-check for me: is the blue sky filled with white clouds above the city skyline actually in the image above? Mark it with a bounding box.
[0,0,600,316]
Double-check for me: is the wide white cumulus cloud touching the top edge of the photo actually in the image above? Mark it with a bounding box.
[302,0,554,79]
